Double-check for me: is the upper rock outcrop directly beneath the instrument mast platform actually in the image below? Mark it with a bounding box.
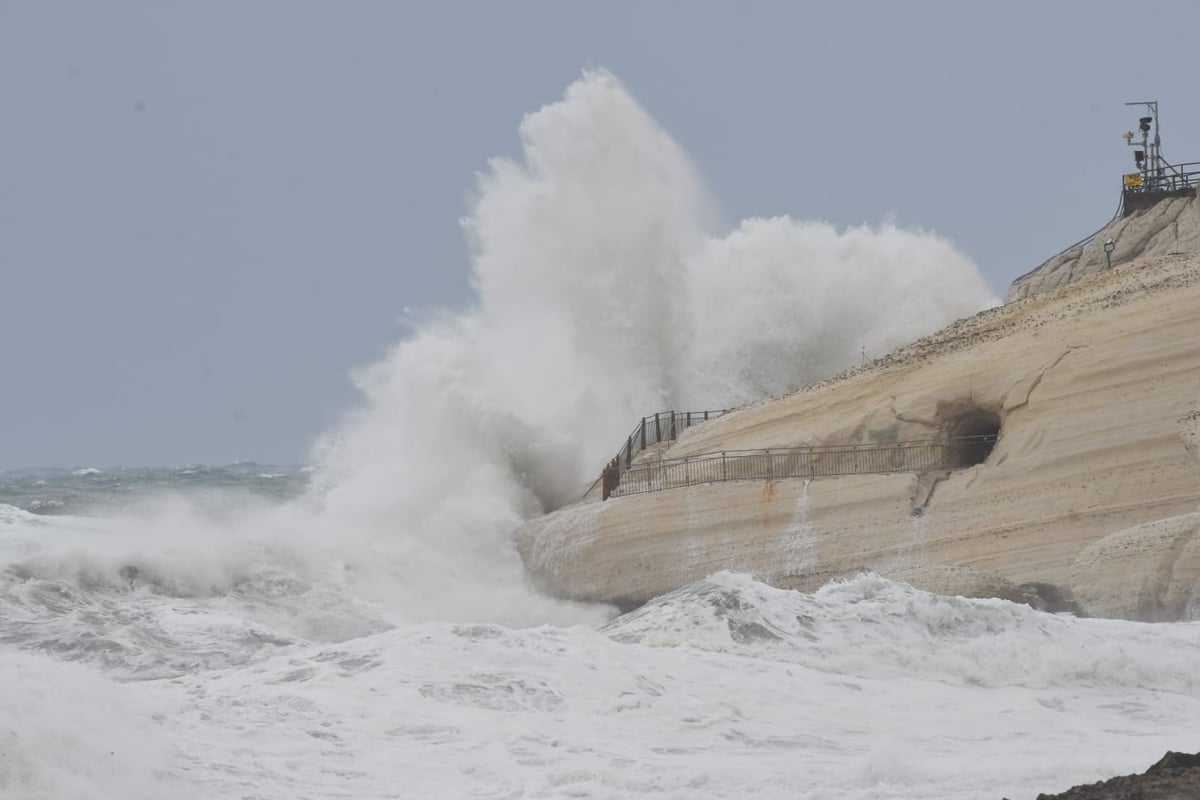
[1004,197,1200,302]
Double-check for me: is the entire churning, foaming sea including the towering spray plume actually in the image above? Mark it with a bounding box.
[0,72,1200,800]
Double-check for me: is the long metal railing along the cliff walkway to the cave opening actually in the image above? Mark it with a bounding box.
[602,434,996,500]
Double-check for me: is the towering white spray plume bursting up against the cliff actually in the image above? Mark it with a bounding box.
[295,72,991,618]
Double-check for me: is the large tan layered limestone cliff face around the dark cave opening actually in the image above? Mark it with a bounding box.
[517,254,1200,619]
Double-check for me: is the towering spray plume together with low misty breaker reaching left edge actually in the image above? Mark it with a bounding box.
[0,71,991,639]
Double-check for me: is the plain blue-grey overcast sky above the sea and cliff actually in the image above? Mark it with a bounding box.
[0,0,1200,469]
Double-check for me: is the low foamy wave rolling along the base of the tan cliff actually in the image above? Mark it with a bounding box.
[601,572,1200,696]
